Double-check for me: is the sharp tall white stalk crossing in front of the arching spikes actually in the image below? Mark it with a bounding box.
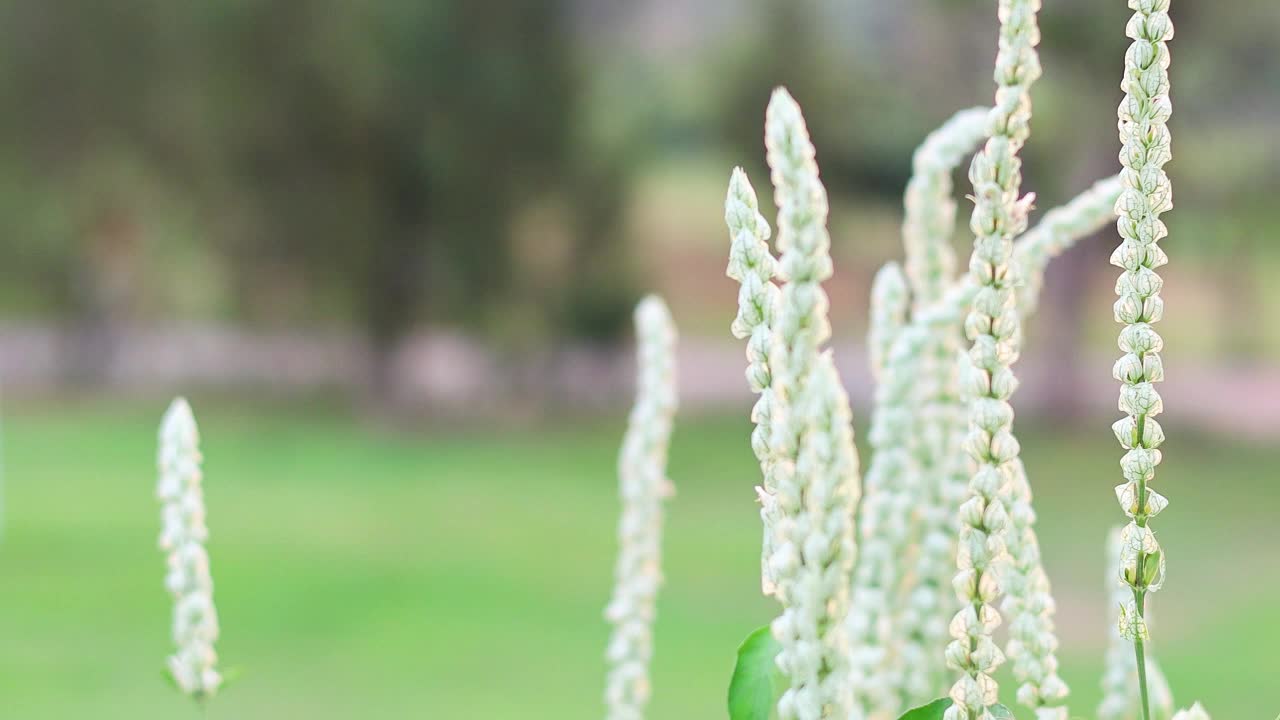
[946,0,1041,720]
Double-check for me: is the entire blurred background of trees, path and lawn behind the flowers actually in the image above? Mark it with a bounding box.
[0,0,1280,720]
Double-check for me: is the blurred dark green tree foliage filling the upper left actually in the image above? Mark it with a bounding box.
[0,0,631,389]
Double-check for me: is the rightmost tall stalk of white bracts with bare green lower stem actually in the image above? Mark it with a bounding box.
[1111,0,1174,720]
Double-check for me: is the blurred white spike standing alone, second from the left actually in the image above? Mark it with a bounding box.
[604,296,676,720]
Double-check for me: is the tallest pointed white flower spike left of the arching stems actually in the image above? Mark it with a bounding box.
[764,88,859,720]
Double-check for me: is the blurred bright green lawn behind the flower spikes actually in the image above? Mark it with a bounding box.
[0,396,1280,720]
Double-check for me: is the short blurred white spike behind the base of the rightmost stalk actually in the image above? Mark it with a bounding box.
[1098,520,1174,720]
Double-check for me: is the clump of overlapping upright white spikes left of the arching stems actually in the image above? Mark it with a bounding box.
[726,88,860,720]
